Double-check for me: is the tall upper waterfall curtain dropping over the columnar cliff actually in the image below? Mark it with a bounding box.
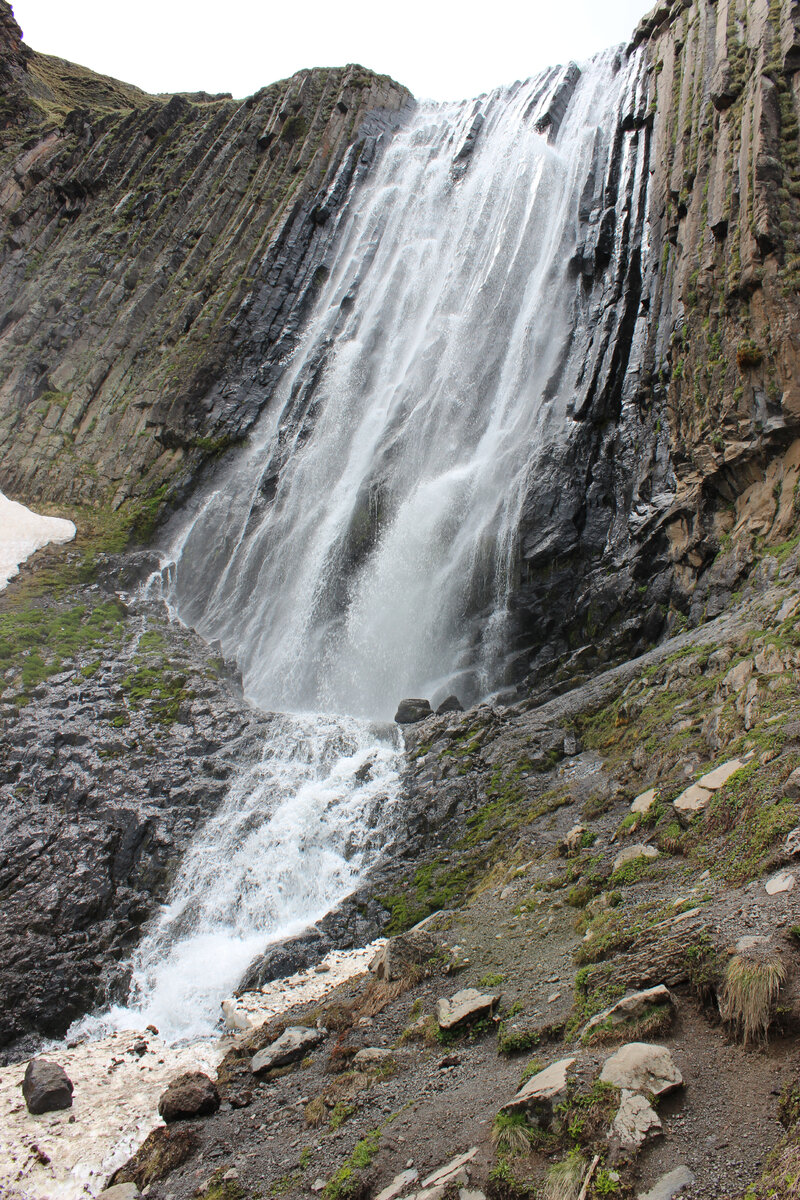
[159,54,647,719]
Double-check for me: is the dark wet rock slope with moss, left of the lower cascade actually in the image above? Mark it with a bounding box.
[0,573,266,1057]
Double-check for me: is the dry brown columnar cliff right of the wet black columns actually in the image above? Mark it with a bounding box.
[634,0,800,586]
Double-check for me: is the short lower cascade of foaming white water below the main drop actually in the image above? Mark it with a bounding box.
[76,715,399,1042]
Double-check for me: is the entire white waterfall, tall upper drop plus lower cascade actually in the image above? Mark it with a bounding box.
[86,53,652,1036]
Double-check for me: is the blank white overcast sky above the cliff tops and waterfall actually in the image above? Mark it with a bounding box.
[12,0,654,100]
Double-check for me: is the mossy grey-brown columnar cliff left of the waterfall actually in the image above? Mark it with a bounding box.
[0,5,410,511]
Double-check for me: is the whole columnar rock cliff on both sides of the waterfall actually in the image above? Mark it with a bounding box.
[0,0,800,679]
